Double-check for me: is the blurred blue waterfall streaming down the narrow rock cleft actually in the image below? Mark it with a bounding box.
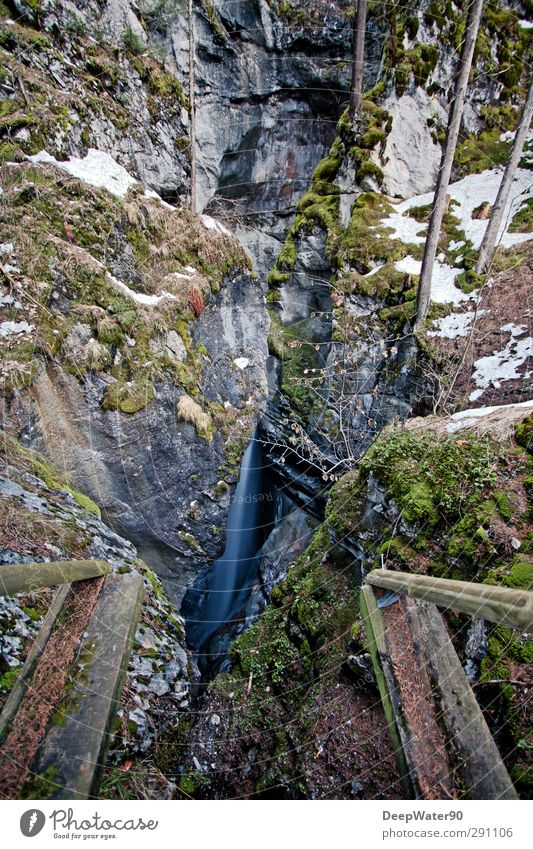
[182,437,271,675]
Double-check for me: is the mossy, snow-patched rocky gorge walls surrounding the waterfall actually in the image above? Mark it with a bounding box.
[0,0,533,799]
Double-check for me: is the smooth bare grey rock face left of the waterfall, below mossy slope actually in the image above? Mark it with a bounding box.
[12,262,268,606]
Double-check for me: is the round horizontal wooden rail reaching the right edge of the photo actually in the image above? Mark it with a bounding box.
[366,569,533,631]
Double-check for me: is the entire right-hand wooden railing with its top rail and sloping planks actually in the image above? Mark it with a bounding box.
[360,569,533,799]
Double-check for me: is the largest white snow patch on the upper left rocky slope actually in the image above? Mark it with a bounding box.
[28,147,138,197]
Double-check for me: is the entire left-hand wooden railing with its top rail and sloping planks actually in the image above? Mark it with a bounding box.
[0,560,144,799]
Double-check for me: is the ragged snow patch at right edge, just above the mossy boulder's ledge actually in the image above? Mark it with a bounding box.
[468,324,533,401]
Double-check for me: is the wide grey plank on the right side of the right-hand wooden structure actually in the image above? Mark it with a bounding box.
[416,602,518,799]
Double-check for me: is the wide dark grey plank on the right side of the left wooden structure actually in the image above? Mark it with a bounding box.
[32,572,144,799]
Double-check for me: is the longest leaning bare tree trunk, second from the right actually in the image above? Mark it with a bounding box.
[415,0,483,331]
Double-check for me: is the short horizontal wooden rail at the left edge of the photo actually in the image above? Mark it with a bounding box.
[0,560,111,595]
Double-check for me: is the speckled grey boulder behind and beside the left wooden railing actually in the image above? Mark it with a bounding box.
[0,440,195,792]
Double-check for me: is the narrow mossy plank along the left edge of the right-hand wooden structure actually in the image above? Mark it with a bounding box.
[359,586,415,799]
